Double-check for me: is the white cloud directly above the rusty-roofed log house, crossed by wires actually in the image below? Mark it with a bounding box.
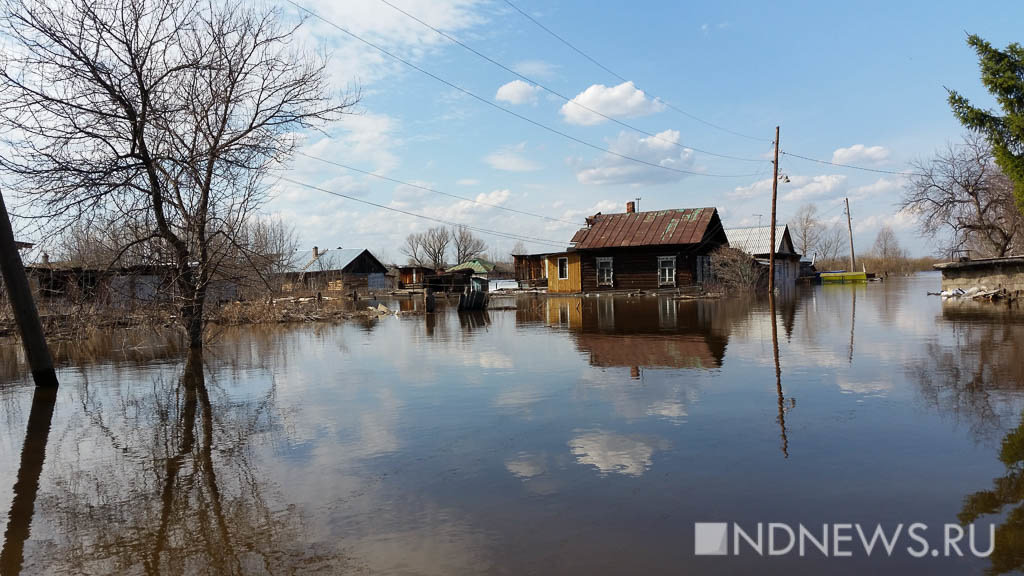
[577,130,693,186]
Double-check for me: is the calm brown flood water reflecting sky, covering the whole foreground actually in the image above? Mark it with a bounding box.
[0,274,1024,575]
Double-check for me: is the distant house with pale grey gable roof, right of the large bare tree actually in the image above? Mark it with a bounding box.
[282,247,388,293]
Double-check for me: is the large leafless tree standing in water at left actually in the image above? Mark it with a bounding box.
[0,0,356,348]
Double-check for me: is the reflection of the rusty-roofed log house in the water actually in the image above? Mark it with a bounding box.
[517,296,728,378]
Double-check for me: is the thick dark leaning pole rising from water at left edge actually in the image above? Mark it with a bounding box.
[0,188,57,386]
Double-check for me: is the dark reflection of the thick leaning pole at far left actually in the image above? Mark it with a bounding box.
[0,386,57,576]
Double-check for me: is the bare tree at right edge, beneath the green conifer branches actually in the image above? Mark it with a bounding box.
[902,133,1024,256]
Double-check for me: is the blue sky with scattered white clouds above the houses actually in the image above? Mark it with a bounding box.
[266,0,1024,261]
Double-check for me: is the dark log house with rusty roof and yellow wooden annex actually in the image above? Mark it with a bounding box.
[547,202,728,292]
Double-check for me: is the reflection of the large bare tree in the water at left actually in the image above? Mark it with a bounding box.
[3,353,345,575]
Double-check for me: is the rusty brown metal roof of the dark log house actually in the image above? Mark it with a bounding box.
[572,208,718,250]
